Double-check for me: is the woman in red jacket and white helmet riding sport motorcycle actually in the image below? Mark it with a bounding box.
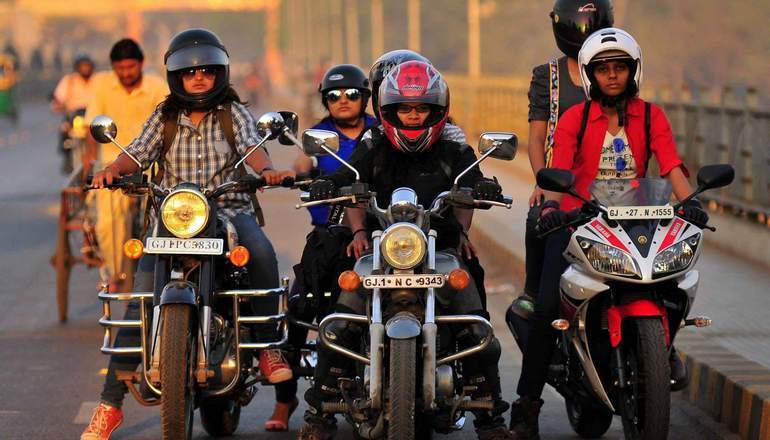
[511,28,708,439]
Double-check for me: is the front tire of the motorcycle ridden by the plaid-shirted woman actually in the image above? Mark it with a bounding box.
[160,304,195,440]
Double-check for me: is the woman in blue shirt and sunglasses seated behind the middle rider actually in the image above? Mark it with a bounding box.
[265,64,377,431]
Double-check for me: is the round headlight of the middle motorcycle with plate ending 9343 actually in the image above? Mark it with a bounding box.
[380,223,428,269]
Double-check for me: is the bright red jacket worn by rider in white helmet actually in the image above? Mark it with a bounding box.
[551,98,689,211]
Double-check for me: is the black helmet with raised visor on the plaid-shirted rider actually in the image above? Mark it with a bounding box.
[164,28,230,110]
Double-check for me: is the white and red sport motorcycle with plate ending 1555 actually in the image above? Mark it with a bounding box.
[506,165,734,440]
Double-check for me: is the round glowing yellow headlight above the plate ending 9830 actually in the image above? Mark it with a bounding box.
[160,189,209,238]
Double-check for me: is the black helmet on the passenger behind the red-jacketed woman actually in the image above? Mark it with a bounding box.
[551,0,615,59]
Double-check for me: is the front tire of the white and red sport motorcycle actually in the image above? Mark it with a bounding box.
[620,318,671,440]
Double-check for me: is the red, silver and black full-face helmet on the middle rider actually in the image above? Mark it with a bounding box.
[378,61,449,153]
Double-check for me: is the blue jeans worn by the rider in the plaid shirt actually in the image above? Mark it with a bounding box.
[101,214,278,408]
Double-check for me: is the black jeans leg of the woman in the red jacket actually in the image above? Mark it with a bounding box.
[516,230,572,398]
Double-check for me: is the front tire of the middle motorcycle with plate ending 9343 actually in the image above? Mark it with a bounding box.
[388,338,417,440]
